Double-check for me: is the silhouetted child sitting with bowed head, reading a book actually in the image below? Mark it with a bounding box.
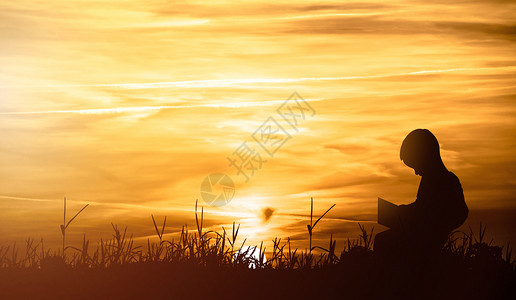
[374,129,468,259]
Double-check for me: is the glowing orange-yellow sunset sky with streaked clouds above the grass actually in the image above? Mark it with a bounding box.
[0,0,516,253]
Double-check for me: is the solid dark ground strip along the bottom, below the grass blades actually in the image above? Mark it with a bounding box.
[0,257,516,299]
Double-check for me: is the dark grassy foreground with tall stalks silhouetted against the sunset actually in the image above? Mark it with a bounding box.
[0,199,516,299]
